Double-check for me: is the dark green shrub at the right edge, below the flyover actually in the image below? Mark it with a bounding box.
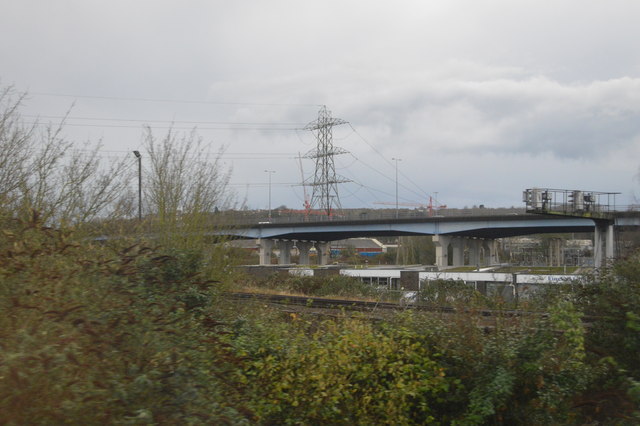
[574,252,640,423]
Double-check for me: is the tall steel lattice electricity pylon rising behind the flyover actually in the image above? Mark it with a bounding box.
[304,105,349,217]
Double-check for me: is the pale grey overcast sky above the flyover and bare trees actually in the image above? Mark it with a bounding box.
[0,0,640,208]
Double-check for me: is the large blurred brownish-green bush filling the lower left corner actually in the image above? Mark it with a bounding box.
[0,218,249,424]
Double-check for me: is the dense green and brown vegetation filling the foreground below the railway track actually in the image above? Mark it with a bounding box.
[0,215,640,424]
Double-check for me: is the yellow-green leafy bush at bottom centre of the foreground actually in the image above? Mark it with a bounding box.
[240,320,449,424]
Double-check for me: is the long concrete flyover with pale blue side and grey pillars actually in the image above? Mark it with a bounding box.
[218,212,640,267]
